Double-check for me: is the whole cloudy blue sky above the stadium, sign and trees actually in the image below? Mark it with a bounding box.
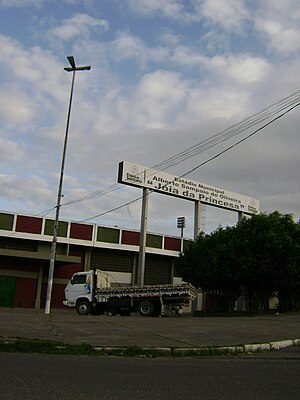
[0,0,300,238]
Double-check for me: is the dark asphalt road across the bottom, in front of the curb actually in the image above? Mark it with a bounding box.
[0,347,300,400]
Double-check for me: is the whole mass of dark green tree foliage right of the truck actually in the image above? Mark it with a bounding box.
[177,211,300,312]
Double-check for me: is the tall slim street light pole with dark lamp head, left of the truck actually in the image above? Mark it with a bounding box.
[45,56,91,314]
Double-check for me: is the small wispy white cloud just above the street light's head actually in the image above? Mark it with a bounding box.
[49,14,109,41]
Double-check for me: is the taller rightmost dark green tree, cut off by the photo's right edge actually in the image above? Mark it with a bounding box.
[236,211,300,312]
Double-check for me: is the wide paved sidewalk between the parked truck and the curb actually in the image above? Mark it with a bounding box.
[0,308,300,349]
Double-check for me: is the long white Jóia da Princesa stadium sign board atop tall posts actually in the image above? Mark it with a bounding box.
[118,161,259,214]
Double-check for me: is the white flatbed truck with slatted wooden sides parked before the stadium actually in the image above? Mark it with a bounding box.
[63,269,196,317]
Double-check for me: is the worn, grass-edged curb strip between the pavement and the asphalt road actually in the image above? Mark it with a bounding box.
[0,338,300,358]
